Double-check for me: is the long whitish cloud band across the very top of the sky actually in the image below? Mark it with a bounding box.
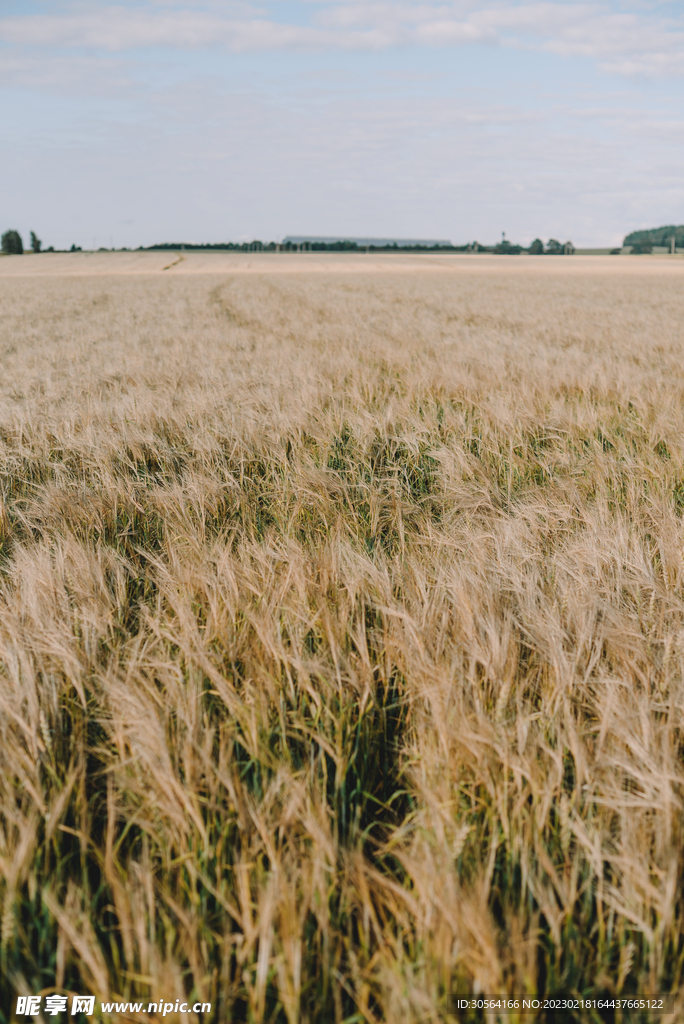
[0,0,684,75]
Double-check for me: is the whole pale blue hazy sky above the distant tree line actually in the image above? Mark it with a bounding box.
[0,0,684,248]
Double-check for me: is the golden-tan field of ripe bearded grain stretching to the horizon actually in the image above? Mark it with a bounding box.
[0,253,684,1024]
